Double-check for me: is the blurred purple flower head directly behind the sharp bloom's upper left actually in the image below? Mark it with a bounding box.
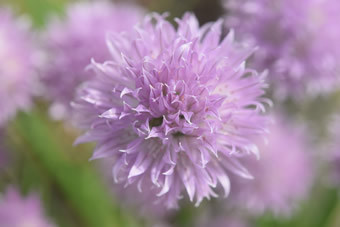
[43,1,143,118]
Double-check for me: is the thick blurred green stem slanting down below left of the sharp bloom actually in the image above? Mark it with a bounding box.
[13,110,138,227]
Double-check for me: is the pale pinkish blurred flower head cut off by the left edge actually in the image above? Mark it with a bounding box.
[0,9,34,127]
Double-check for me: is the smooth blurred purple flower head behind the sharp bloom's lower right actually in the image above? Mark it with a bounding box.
[231,116,313,215]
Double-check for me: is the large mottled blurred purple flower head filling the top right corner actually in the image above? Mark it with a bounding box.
[226,0,340,98]
